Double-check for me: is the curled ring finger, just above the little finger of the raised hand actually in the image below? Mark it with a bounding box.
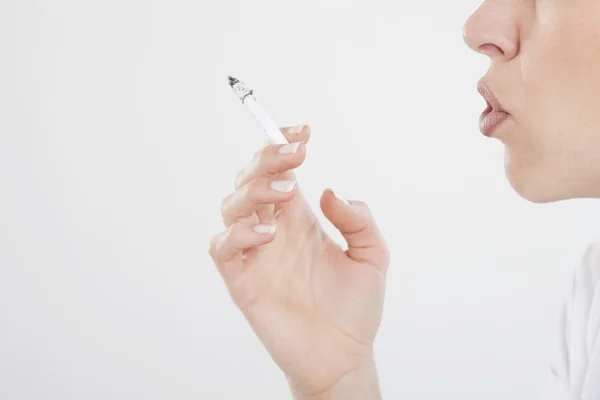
[221,178,297,226]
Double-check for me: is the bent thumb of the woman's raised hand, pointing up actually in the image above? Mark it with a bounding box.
[321,189,389,270]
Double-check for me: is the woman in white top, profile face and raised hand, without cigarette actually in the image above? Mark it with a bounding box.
[210,0,600,400]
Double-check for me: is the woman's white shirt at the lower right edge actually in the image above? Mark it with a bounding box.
[544,242,600,400]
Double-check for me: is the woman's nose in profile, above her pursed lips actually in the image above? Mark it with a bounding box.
[463,0,519,61]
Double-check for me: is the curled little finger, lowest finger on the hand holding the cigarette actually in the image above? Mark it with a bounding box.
[209,222,276,267]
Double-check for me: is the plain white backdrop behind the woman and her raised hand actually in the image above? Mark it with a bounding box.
[0,0,600,400]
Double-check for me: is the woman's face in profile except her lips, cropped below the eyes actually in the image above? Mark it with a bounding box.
[464,0,600,202]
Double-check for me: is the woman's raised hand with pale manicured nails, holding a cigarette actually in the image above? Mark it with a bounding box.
[209,126,389,400]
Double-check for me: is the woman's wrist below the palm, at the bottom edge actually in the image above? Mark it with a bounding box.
[292,360,382,400]
